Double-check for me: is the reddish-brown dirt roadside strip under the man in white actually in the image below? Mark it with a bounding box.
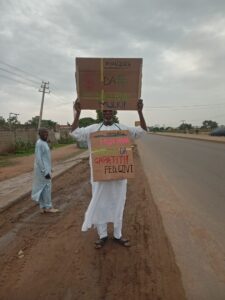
[0,149,185,300]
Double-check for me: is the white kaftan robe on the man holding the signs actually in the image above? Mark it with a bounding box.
[71,124,145,231]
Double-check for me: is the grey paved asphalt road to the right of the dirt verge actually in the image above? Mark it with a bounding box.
[138,134,225,300]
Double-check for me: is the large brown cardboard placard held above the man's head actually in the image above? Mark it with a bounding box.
[75,57,142,110]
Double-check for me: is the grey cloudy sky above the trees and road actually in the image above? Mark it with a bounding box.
[0,0,225,126]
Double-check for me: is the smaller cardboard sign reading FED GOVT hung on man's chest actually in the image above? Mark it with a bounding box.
[90,130,135,181]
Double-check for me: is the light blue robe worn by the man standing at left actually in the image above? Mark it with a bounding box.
[31,139,52,202]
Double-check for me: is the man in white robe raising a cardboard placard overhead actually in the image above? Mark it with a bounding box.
[71,100,147,249]
